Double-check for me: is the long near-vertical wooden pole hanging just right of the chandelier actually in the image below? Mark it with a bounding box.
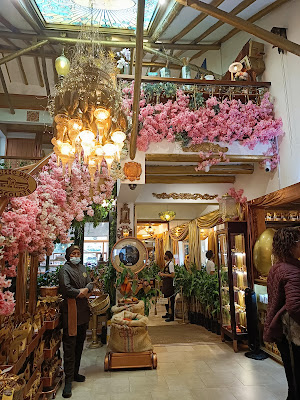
[130,0,145,160]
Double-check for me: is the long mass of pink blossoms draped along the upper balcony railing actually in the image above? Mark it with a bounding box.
[123,83,283,165]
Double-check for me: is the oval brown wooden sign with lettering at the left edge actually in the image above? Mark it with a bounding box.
[0,169,36,197]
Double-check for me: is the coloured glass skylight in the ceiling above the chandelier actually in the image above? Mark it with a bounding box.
[34,0,159,29]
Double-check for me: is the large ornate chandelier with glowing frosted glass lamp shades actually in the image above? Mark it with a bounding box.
[49,28,128,181]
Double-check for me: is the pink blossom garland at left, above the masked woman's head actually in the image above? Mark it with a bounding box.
[0,155,115,315]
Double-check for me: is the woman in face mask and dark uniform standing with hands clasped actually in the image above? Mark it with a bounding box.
[59,245,93,398]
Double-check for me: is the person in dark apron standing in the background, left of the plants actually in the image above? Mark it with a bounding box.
[159,251,175,322]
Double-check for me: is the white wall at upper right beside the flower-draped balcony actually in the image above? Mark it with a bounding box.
[221,0,300,190]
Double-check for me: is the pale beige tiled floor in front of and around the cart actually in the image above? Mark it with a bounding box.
[57,304,287,400]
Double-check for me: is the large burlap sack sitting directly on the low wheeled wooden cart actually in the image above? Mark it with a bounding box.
[108,311,153,353]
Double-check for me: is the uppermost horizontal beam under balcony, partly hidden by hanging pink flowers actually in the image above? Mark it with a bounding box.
[146,153,271,163]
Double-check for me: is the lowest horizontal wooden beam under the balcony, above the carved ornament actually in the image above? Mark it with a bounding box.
[146,175,235,185]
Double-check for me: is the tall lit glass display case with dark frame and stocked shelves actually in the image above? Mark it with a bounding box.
[216,222,252,351]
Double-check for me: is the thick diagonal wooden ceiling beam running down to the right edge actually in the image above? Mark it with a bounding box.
[176,0,300,56]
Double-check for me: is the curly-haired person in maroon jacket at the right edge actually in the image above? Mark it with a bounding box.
[264,228,300,400]
